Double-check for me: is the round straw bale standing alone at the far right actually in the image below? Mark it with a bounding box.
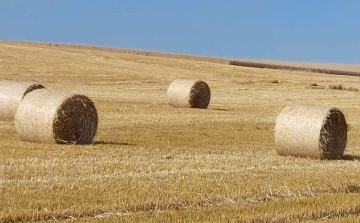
[275,105,347,159]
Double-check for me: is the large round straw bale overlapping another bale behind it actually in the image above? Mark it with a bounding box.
[15,89,98,144]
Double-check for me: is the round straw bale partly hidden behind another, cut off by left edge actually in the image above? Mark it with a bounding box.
[0,81,44,120]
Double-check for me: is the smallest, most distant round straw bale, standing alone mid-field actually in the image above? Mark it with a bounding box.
[167,79,211,108]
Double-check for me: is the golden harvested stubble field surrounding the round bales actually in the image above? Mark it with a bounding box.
[0,42,360,223]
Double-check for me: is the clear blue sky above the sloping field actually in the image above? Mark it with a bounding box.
[0,0,360,63]
